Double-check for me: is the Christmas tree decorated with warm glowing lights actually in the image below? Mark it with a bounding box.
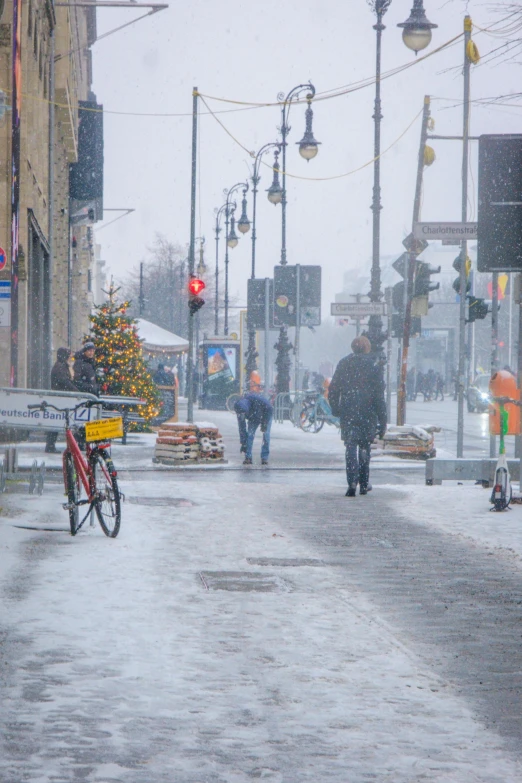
[90,280,160,421]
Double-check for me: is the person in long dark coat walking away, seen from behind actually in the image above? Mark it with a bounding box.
[328,337,387,497]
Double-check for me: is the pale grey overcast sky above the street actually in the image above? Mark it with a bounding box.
[93,0,521,314]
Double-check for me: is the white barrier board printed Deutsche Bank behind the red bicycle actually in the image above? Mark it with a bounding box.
[0,387,101,430]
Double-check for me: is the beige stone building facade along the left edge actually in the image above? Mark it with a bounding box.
[0,0,103,388]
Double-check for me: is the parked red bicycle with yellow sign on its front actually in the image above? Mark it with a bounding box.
[28,402,123,538]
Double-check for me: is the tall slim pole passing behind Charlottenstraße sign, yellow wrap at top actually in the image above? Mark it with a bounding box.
[457,14,471,458]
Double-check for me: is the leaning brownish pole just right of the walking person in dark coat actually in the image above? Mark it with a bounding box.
[397,95,430,425]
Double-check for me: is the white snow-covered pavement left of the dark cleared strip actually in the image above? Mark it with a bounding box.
[0,462,522,783]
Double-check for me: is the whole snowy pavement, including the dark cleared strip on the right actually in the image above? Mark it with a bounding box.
[0,414,522,783]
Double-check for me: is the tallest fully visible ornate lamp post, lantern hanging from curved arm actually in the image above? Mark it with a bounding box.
[269,82,320,393]
